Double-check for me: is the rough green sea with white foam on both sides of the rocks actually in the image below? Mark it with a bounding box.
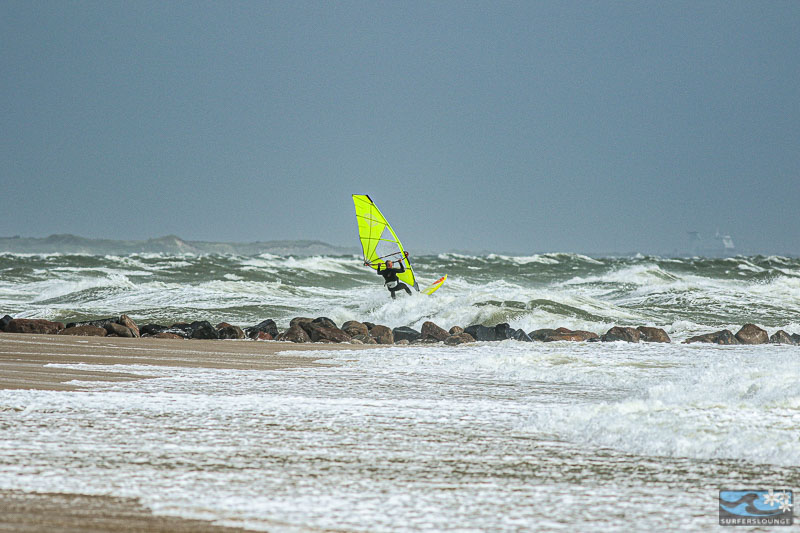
[0,253,800,532]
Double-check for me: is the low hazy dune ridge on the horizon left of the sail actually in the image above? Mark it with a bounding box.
[0,234,358,256]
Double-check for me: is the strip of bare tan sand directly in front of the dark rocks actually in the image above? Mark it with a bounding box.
[0,333,370,391]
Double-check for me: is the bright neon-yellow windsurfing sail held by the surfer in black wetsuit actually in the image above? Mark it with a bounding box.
[353,194,419,291]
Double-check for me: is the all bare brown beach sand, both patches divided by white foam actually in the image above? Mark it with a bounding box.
[0,333,368,533]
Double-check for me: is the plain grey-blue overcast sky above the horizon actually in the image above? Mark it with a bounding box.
[0,0,800,253]
